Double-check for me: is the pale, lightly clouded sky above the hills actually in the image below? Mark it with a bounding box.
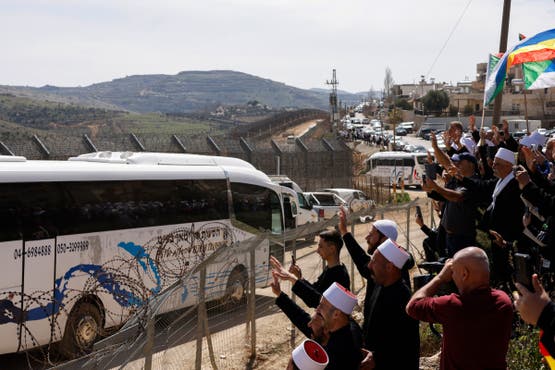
[0,0,555,92]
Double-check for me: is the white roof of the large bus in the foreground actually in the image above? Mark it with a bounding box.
[0,152,275,189]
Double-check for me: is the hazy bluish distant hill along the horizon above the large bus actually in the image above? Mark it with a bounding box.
[0,71,358,113]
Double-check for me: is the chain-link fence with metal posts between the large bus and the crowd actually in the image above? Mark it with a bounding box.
[28,199,434,370]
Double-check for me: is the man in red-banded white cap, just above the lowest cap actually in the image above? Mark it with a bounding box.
[316,283,362,370]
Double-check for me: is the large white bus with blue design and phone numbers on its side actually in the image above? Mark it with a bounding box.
[0,152,283,355]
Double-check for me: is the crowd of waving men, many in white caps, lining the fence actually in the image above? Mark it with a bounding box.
[278,119,555,370]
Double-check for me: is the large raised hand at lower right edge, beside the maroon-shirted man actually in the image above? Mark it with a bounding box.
[513,274,551,325]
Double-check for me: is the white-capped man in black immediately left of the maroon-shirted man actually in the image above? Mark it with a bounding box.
[361,239,420,370]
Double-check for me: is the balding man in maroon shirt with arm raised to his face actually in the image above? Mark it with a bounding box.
[406,247,513,370]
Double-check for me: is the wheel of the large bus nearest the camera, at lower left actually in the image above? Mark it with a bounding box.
[59,302,102,358]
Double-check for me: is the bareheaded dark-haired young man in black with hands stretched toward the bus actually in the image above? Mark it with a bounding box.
[270,230,351,308]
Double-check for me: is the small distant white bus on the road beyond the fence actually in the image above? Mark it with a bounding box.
[366,152,427,186]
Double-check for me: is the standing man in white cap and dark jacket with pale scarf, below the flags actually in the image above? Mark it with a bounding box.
[462,148,524,285]
